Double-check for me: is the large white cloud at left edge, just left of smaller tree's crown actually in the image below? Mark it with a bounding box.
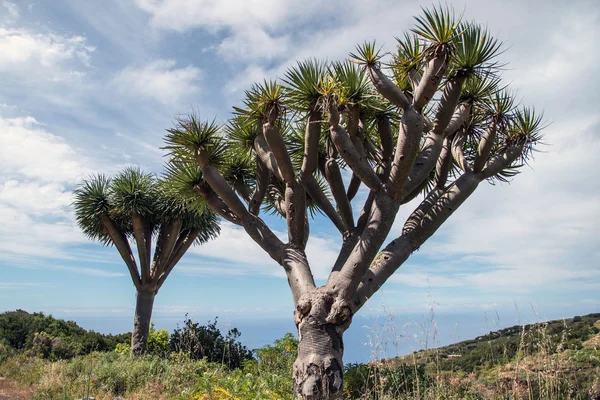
[0,116,92,264]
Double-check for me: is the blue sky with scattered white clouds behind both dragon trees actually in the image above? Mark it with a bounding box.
[0,0,600,358]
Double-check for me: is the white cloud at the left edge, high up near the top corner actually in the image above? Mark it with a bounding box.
[0,26,94,80]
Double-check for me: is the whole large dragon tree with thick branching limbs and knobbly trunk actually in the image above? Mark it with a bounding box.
[165,7,542,399]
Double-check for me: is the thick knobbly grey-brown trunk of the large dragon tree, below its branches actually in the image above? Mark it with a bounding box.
[294,289,350,400]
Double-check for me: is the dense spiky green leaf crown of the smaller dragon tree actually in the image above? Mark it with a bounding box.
[73,166,219,245]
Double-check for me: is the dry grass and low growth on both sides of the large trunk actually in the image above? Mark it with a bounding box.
[0,312,600,400]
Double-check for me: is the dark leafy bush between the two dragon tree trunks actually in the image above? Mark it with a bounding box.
[169,315,253,369]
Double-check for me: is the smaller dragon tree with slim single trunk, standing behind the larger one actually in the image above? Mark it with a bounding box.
[73,167,220,357]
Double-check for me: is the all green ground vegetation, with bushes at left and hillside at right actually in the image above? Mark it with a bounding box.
[0,311,600,400]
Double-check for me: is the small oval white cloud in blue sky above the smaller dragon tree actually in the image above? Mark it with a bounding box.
[114,60,202,104]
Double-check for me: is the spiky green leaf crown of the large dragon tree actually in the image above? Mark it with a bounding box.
[166,6,539,220]
